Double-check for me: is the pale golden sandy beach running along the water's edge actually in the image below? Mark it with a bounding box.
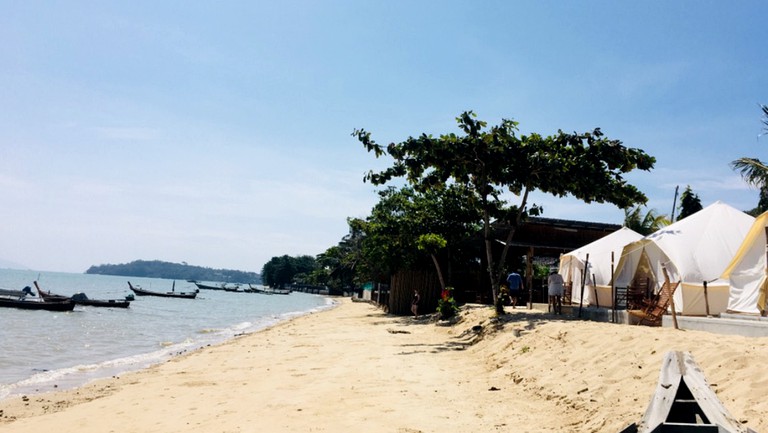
[0,299,768,433]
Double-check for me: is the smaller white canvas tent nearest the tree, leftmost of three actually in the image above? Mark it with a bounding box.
[559,227,643,307]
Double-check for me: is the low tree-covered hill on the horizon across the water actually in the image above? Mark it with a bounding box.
[85,260,261,284]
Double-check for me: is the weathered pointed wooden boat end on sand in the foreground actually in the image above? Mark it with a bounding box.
[620,352,754,433]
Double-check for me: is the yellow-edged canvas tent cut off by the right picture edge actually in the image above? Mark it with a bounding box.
[721,212,768,314]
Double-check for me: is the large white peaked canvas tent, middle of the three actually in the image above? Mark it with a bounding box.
[614,201,755,316]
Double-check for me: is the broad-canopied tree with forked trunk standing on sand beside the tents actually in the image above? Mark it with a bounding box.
[353,111,655,303]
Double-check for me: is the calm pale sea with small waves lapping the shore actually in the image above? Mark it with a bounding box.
[0,269,333,400]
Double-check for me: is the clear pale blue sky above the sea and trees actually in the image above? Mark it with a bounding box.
[0,0,768,272]
